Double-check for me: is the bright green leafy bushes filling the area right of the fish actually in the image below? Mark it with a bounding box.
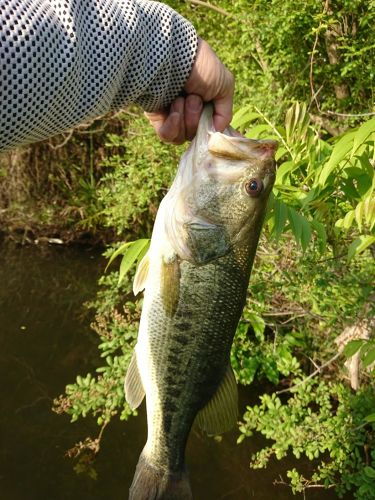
[232,103,375,500]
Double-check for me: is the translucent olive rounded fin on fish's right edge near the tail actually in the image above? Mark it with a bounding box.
[196,365,238,435]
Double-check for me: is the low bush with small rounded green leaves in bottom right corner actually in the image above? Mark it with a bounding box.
[239,379,375,500]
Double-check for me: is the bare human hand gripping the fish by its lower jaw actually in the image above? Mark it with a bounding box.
[145,39,234,144]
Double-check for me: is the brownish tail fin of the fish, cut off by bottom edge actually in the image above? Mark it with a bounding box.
[129,453,193,500]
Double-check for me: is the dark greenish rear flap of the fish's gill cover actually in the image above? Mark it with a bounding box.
[186,219,230,265]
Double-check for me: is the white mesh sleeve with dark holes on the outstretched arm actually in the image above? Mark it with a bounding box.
[0,0,197,151]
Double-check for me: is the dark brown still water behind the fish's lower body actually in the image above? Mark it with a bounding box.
[0,245,346,500]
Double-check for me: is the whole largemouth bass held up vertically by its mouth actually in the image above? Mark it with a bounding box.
[125,104,277,500]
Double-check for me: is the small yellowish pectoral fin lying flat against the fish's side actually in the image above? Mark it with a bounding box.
[160,256,180,317]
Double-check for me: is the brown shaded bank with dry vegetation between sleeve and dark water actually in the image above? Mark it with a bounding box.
[0,112,137,246]
